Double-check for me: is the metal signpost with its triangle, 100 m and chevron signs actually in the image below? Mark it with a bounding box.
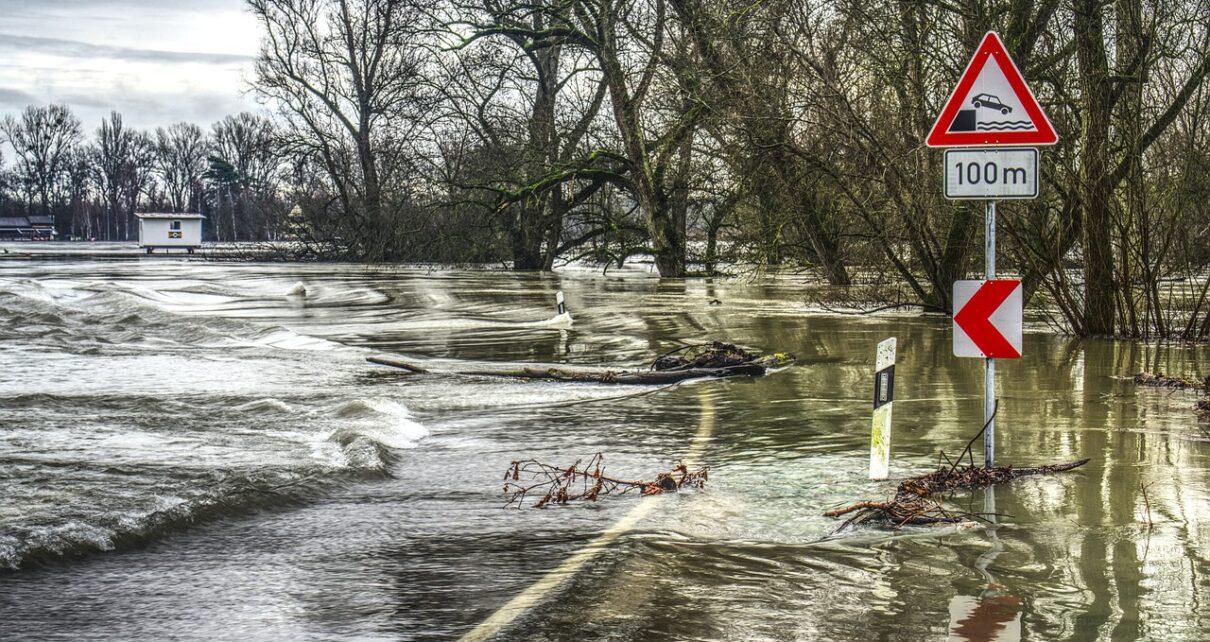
[924,31,1059,467]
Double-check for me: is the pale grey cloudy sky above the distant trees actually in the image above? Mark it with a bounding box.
[0,0,261,135]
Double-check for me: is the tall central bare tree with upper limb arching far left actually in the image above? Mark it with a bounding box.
[459,0,702,277]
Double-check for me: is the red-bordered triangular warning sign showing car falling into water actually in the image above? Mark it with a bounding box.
[924,31,1059,148]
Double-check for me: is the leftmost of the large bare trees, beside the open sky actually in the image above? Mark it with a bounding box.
[248,0,425,260]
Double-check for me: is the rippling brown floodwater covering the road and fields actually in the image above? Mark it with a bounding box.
[0,258,1210,641]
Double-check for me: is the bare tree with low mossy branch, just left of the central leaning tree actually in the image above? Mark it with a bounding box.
[439,0,618,270]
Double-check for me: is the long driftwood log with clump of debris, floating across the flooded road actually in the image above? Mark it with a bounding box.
[365,342,795,386]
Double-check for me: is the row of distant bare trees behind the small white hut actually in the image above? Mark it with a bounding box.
[0,105,289,241]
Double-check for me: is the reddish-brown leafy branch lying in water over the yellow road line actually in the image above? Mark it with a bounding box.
[505,452,709,508]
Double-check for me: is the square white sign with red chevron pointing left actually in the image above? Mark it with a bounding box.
[953,279,1024,359]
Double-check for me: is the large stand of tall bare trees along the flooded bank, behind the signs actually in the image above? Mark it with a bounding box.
[2,0,1210,339]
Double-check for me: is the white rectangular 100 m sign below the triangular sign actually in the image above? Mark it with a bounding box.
[945,148,1038,199]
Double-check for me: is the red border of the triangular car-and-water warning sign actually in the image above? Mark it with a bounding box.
[924,31,1059,148]
